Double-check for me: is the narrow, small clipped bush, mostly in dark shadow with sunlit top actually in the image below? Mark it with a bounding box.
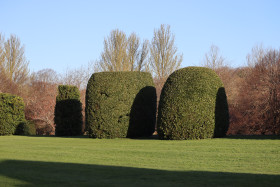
[54,85,83,136]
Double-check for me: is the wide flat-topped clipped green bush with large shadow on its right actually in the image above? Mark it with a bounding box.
[85,72,156,138]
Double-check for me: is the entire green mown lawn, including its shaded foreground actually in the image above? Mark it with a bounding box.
[0,136,280,186]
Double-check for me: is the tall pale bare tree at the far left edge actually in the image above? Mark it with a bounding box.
[0,35,29,84]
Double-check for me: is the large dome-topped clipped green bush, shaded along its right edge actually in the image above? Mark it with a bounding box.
[157,67,229,140]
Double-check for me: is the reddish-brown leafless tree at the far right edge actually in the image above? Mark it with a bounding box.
[239,49,280,134]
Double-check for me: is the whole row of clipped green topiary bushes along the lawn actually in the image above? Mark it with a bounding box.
[0,67,229,140]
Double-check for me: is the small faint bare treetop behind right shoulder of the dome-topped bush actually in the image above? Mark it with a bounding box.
[202,45,226,71]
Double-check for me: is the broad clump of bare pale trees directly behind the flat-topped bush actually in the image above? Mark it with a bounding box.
[95,29,148,72]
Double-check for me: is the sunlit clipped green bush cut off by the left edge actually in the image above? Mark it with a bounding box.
[0,93,25,135]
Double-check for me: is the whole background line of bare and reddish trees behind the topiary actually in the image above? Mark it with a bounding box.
[0,25,280,135]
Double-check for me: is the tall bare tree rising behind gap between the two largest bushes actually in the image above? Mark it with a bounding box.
[149,25,183,79]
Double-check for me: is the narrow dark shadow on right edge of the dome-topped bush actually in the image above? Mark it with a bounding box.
[214,87,229,138]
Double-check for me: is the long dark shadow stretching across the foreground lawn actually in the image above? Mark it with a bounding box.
[0,160,280,186]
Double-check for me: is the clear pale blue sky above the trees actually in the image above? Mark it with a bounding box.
[0,0,280,73]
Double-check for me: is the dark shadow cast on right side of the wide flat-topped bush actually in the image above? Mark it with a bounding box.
[127,86,157,138]
